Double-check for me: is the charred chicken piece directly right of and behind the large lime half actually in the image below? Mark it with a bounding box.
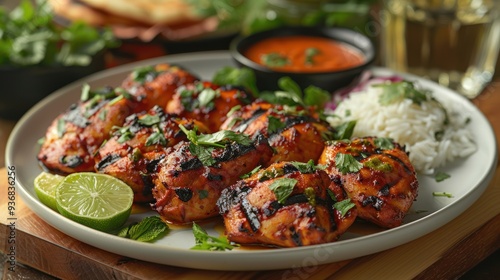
[95,106,208,202]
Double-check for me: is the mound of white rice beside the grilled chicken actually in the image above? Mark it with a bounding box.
[327,81,476,174]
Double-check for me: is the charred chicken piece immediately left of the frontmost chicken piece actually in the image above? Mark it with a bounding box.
[152,137,273,224]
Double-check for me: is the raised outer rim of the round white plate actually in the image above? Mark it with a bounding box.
[5,51,498,271]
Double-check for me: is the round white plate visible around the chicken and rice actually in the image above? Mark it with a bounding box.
[6,52,497,270]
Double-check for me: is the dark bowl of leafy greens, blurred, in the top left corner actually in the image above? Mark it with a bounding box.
[0,0,119,120]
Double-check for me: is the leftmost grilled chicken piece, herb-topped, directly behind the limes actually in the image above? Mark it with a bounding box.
[37,88,133,175]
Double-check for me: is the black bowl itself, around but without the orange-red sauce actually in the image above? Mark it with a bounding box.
[230,26,375,92]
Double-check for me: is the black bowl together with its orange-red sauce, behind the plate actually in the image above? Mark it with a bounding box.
[230,26,375,92]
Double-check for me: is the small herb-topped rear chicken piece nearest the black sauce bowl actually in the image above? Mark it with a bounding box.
[167,82,251,132]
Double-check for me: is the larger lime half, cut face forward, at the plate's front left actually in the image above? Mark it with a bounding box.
[56,172,134,231]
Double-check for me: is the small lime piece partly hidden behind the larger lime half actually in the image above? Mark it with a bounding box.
[34,172,64,211]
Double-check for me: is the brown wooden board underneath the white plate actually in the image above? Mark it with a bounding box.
[0,80,500,279]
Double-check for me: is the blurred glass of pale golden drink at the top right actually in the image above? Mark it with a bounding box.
[380,0,500,98]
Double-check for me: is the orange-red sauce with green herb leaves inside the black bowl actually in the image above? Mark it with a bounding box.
[244,36,365,72]
